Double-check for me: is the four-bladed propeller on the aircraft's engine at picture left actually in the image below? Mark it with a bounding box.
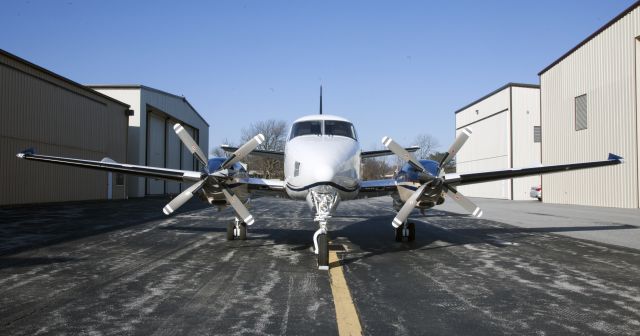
[162,123,265,225]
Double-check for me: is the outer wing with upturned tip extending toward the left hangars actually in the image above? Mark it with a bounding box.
[17,149,202,182]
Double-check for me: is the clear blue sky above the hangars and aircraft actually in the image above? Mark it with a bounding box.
[0,0,634,150]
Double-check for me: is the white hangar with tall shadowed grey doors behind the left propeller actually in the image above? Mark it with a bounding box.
[89,85,209,197]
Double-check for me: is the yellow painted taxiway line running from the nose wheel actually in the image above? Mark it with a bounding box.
[329,250,362,336]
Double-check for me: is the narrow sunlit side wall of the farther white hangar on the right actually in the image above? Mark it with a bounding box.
[511,86,541,200]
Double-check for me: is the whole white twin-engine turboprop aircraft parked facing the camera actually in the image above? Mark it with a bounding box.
[18,114,623,270]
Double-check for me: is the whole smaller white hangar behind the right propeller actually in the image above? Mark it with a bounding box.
[455,83,541,200]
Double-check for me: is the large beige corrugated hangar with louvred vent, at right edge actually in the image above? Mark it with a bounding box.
[539,2,640,208]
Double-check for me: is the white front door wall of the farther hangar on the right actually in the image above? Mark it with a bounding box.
[456,88,511,199]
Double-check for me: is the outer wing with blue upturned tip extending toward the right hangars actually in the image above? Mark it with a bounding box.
[444,154,624,186]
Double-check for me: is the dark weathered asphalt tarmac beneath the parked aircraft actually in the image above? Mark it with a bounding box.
[0,198,640,335]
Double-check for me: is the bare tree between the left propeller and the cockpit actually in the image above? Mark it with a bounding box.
[242,119,288,179]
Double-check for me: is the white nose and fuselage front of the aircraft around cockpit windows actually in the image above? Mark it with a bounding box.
[284,115,360,200]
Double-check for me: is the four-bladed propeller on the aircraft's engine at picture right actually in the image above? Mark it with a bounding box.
[382,128,482,228]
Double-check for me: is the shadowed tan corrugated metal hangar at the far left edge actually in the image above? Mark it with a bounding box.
[0,49,131,205]
